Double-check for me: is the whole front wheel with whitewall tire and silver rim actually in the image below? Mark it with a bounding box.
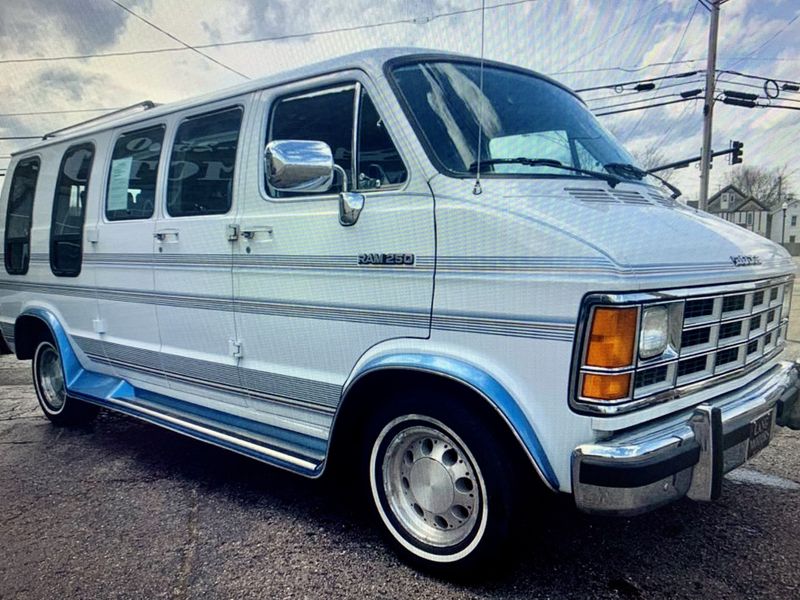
[369,398,516,577]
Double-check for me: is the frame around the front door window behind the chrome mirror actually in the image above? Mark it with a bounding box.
[256,70,412,203]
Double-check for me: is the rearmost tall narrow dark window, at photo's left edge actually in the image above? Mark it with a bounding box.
[5,158,39,275]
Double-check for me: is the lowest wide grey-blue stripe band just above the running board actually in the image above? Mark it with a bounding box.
[73,336,342,415]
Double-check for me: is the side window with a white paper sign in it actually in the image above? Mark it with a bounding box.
[106,125,164,221]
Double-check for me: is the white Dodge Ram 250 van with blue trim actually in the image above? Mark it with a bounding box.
[0,50,798,570]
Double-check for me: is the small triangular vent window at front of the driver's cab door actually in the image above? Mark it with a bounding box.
[356,91,408,190]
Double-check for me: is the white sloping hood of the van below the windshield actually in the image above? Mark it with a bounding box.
[432,179,795,279]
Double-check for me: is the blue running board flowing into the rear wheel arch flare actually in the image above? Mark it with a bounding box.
[23,308,327,477]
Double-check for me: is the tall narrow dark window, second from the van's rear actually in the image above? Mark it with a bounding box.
[50,144,94,277]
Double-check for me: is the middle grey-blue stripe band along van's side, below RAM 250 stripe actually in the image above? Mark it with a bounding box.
[0,281,575,341]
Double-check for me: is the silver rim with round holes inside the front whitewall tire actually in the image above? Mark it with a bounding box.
[373,415,486,551]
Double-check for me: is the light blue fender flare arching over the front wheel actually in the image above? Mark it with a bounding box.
[359,353,558,490]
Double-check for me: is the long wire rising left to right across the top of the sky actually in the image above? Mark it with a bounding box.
[0,0,540,64]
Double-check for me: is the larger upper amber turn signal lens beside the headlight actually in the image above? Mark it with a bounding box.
[586,308,639,368]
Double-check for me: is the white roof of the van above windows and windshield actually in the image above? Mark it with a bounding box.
[11,47,574,157]
